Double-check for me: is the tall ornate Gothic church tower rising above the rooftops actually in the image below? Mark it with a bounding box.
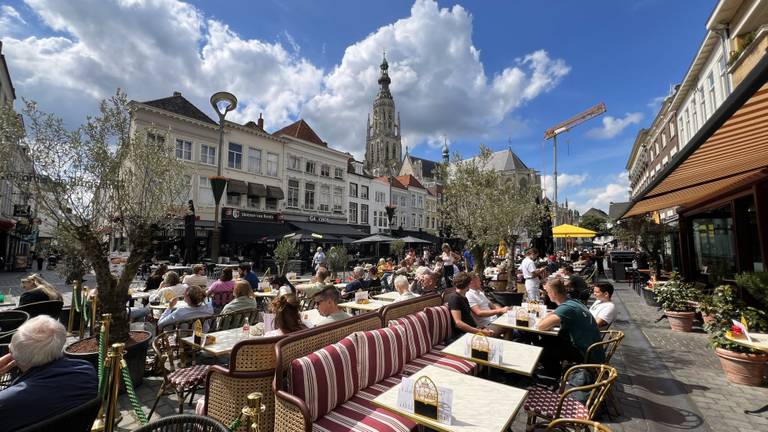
[365,56,402,176]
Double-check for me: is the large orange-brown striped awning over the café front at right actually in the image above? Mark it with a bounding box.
[622,54,768,218]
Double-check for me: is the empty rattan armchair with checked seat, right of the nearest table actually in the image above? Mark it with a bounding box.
[523,364,618,431]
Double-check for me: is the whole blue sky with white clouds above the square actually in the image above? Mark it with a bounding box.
[0,0,715,210]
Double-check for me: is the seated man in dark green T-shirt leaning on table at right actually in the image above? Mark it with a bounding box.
[536,278,605,378]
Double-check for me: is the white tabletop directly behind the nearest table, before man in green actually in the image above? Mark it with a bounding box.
[443,333,542,376]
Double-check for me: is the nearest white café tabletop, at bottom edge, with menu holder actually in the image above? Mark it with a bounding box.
[372,365,528,432]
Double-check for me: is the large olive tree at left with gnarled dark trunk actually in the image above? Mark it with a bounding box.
[0,90,187,342]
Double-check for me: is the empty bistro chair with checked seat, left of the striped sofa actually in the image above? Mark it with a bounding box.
[147,330,208,418]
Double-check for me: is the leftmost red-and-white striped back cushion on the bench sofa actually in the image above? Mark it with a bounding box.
[289,336,360,421]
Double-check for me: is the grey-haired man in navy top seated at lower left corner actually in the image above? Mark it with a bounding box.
[0,315,98,430]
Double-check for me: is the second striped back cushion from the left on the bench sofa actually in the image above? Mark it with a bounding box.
[353,326,406,388]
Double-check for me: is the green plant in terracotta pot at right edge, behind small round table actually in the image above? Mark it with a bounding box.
[704,285,768,386]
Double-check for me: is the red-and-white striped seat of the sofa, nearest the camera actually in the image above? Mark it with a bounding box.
[312,375,417,432]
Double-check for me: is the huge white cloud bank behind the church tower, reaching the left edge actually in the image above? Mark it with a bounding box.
[0,0,570,157]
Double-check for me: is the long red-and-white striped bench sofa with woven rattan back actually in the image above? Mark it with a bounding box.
[274,299,474,432]
